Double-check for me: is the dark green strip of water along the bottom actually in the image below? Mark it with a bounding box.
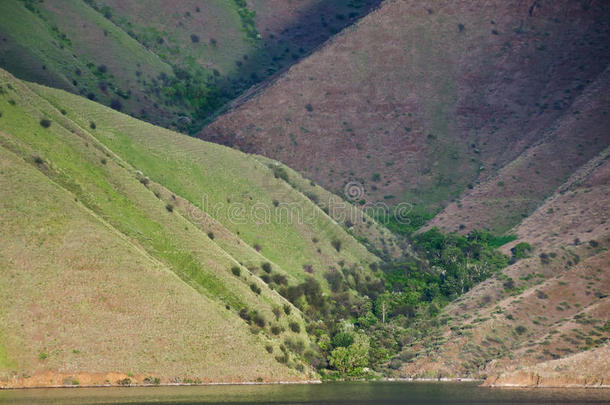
[0,382,610,405]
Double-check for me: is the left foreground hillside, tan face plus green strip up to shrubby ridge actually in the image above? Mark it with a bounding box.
[0,68,332,384]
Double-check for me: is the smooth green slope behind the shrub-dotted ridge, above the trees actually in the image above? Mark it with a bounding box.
[31,79,384,280]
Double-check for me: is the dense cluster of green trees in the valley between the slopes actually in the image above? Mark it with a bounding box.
[270,229,508,377]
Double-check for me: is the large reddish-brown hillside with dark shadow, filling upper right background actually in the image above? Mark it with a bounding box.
[199,1,610,230]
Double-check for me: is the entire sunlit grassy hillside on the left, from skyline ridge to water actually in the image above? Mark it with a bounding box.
[0,68,392,386]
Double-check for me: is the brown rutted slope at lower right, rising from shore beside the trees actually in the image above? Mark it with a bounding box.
[394,149,610,380]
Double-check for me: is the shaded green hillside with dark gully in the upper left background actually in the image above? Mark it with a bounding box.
[0,0,380,131]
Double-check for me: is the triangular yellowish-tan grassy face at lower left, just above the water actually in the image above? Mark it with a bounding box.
[0,141,298,385]
